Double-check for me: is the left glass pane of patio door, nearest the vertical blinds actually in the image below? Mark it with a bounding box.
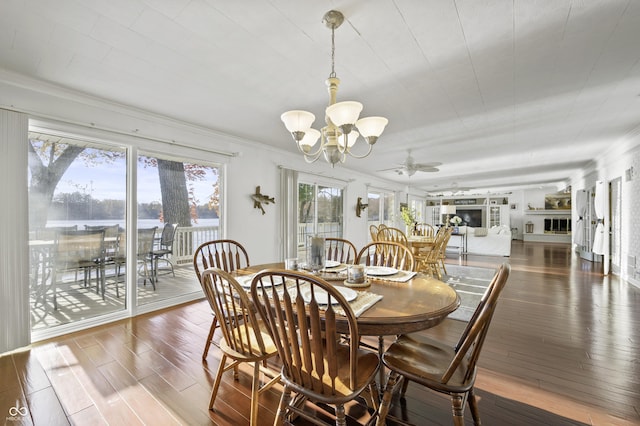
[27,132,127,330]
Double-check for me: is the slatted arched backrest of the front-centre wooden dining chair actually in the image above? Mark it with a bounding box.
[251,269,360,396]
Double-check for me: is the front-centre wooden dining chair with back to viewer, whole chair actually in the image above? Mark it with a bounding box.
[251,269,380,425]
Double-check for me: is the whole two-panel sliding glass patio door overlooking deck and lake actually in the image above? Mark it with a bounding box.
[26,127,223,336]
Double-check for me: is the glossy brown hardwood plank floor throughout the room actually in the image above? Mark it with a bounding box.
[0,241,640,425]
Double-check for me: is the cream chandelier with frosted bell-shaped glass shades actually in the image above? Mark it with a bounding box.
[280,10,389,167]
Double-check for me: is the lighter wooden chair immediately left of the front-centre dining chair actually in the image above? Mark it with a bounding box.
[201,268,280,426]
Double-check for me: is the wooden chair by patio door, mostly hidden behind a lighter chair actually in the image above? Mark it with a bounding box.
[193,239,249,361]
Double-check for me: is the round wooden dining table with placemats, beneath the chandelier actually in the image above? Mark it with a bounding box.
[235,262,460,385]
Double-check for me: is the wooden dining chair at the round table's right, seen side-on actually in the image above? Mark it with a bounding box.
[378,263,511,426]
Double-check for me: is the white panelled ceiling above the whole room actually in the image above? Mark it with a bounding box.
[0,0,640,191]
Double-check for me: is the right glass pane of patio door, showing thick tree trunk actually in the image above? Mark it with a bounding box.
[136,152,221,305]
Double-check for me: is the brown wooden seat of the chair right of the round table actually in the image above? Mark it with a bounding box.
[382,334,475,392]
